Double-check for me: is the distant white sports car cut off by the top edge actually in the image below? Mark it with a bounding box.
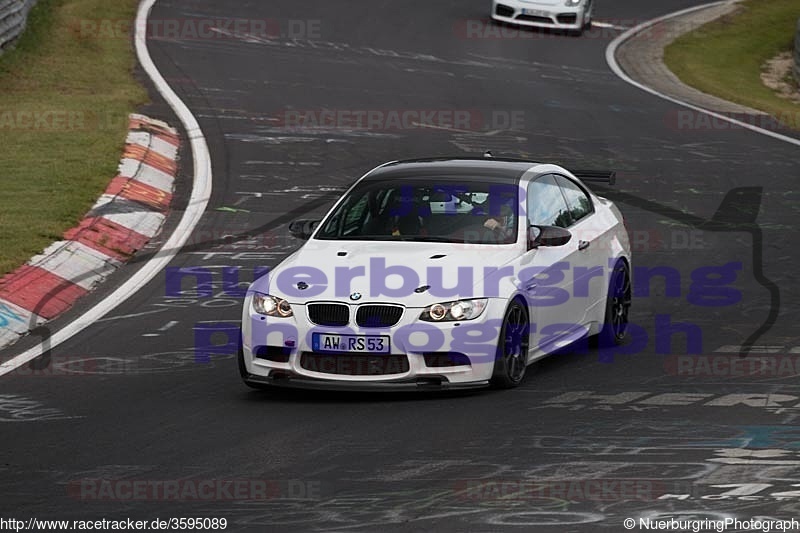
[492,0,594,35]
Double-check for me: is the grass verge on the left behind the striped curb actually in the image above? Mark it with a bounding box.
[0,0,147,275]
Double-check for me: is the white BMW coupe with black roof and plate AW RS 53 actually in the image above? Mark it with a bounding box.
[239,158,631,389]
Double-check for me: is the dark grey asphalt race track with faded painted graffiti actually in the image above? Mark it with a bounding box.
[0,0,800,532]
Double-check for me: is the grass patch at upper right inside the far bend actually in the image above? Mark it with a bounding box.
[664,0,800,129]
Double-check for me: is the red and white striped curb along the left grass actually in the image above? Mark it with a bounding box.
[0,115,179,348]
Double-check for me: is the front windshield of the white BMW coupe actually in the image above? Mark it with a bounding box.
[316,178,519,244]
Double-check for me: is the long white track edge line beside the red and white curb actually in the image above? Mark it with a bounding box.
[0,0,212,376]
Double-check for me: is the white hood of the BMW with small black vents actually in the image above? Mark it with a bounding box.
[251,240,521,307]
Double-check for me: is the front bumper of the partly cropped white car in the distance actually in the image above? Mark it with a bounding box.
[492,0,586,30]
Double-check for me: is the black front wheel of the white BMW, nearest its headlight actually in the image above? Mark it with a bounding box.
[490,300,530,389]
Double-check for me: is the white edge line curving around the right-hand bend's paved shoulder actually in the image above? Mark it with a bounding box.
[606,0,800,146]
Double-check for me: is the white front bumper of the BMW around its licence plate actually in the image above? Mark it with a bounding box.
[241,296,507,390]
